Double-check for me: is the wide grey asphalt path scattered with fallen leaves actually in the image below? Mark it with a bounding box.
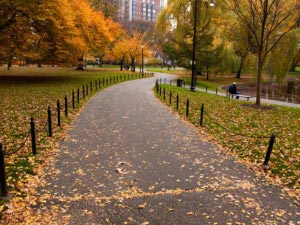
[35,74,300,225]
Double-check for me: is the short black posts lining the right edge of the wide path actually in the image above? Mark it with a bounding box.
[156,83,276,169]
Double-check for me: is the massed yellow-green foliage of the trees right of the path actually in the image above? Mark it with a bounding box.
[156,0,300,105]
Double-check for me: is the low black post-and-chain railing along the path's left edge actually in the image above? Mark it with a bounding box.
[0,73,154,197]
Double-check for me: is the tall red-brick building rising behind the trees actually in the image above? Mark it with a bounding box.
[122,0,166,23]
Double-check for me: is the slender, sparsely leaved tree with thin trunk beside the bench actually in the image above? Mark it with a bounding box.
[229,0,300,105]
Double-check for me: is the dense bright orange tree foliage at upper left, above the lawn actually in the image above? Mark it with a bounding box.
[0,0,123,68]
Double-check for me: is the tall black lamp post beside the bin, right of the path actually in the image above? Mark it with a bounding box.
[190,0,215,91]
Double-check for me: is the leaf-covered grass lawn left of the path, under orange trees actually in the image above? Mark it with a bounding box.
[0,67,138,204]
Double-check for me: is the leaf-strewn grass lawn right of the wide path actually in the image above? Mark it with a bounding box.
[156,85,300,190]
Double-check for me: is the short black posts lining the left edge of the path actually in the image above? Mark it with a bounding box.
[0,74,144,198]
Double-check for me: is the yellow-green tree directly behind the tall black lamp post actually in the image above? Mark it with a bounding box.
[156,0,220,75]
